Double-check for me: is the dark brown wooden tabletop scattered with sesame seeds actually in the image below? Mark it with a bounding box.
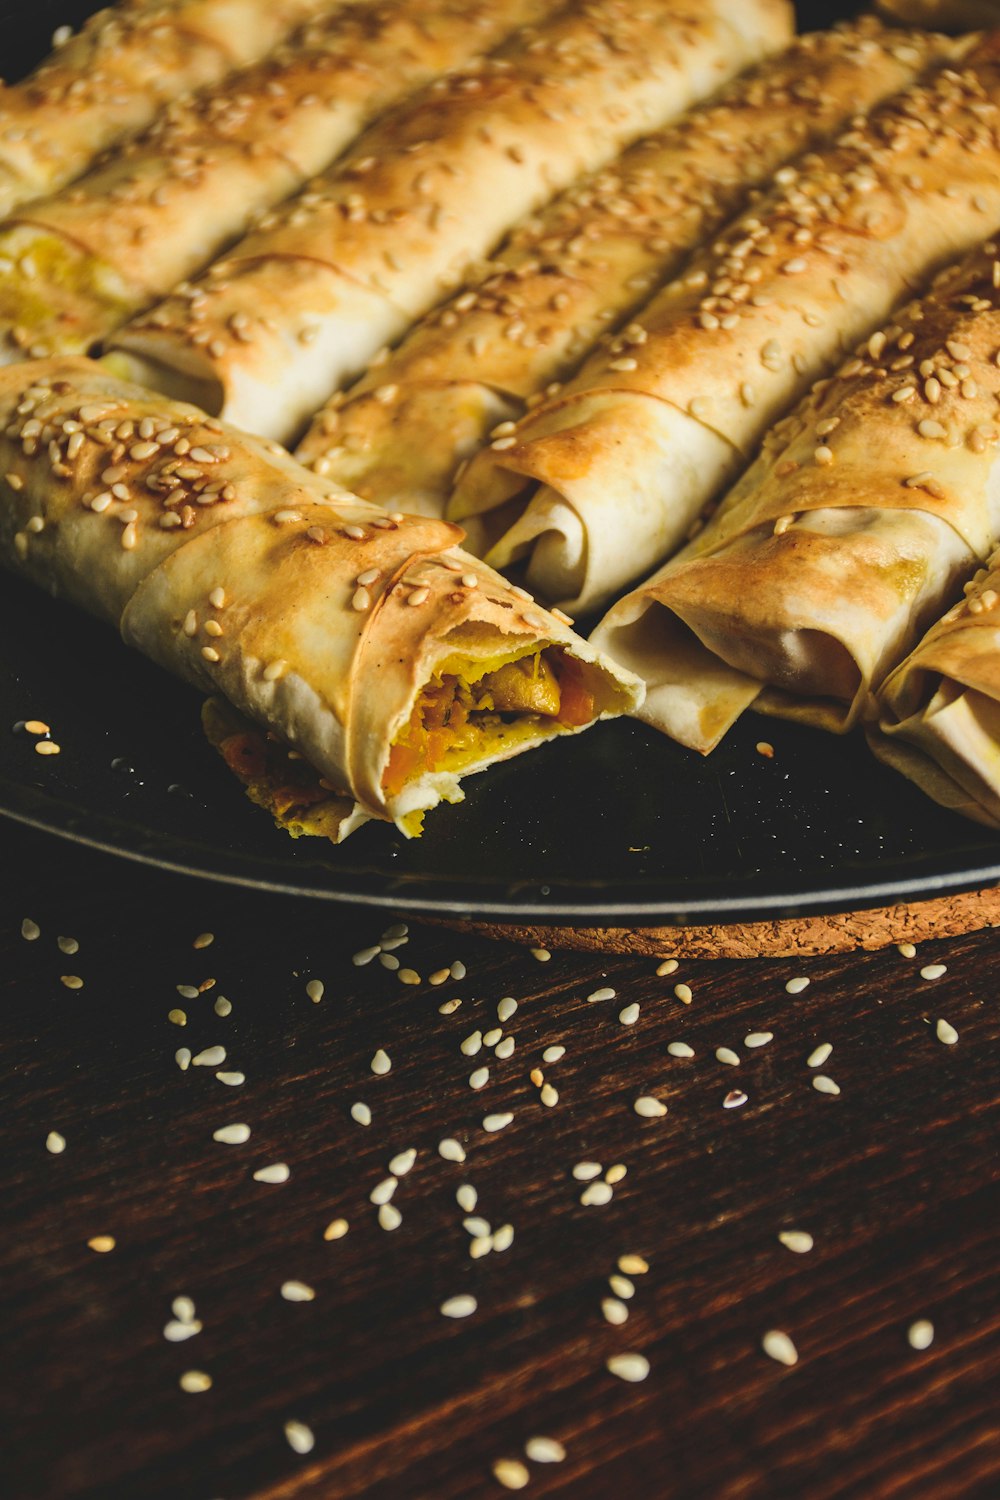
[0,824,1000,1500]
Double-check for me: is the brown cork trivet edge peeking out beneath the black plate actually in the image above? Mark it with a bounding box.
[417,887,1000,959]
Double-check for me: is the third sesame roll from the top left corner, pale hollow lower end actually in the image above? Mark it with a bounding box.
[111,0,790,443]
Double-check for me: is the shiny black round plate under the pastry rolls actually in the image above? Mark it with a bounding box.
[0,3,1000,926]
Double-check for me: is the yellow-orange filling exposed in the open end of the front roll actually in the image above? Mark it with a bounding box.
[382,647,597,798]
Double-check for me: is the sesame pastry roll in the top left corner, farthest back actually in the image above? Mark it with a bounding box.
[0,0,334,215]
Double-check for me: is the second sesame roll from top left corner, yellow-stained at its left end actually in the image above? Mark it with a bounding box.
[0,0,555,363]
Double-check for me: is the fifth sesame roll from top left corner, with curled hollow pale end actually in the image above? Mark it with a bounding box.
[448,32,1000,614]
